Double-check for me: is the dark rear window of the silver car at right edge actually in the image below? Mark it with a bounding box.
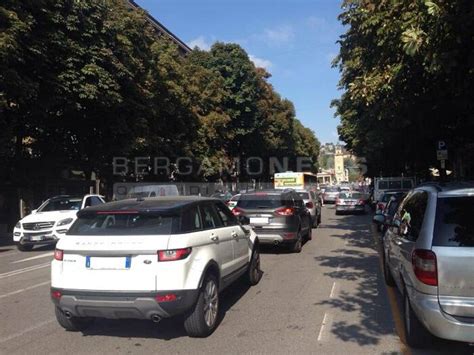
[433,196,474,247]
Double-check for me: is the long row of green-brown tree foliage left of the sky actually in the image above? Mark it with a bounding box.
[0,0,319,186]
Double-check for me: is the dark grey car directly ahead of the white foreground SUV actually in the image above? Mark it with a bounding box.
[232,189,312,253]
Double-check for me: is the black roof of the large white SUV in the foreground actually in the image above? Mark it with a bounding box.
[81,196,220,213]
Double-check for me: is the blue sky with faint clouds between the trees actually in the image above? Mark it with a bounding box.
[136,0,343,143]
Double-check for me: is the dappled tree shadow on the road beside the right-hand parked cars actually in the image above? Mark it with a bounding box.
[315,215,395,346]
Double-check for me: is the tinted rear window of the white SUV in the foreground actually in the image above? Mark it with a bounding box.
[67,213,179,235]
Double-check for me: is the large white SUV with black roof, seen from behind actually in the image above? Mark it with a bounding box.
[51,197,262,337]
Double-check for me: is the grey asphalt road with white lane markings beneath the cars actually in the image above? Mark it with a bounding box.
[0,206,474,354]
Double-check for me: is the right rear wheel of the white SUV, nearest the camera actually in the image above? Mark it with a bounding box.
[184,274,219,338]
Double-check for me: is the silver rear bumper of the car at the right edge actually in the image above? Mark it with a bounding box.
[408,288,474,343]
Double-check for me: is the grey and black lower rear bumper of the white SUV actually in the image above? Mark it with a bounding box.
[51,288,199,319]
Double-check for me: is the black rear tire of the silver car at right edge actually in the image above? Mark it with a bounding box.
[403,290,432,349]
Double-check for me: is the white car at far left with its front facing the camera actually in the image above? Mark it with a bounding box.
[13,195,105,251]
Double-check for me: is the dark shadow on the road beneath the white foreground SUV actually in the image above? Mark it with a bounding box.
[82,280,250,340]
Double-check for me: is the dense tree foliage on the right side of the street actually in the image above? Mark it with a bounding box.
[333,0,474,175]
